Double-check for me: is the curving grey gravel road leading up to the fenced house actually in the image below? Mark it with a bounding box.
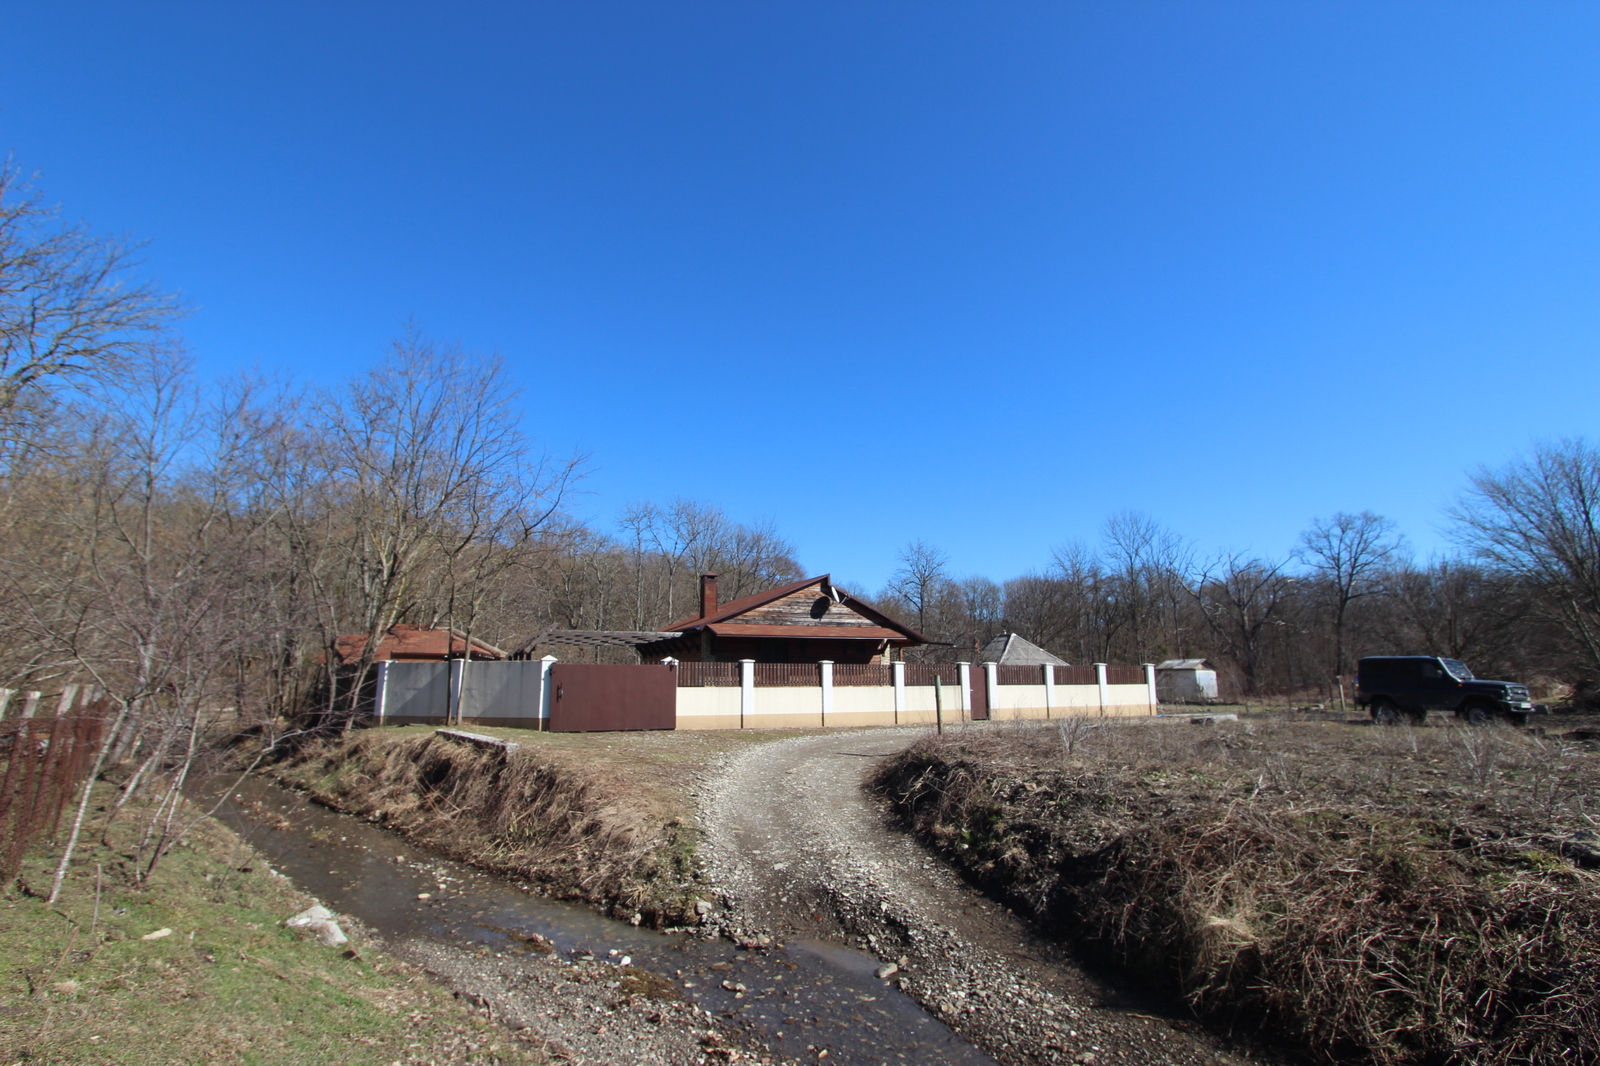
[698,727,1259,1066]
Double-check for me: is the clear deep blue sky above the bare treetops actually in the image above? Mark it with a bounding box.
[0,0,1600,589]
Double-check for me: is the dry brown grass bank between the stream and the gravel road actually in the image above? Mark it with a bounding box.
[280,730,696,925]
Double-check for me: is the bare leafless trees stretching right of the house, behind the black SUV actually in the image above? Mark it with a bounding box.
[878,489,1600,695]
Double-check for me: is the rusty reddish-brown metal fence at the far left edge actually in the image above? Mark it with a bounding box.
[0,701,107,885]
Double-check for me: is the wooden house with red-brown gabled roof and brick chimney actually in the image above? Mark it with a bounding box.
[637,573,928,663]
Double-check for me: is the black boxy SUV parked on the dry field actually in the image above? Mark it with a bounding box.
[1355,655,1547,725]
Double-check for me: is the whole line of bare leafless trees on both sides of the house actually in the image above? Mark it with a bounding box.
[0,161,1600,765]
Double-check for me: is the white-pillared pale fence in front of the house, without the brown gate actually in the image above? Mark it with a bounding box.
[374,656,1157,730]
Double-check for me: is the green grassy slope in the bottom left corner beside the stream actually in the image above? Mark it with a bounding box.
[0,786,544,1066]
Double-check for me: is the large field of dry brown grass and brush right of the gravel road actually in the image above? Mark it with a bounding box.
[875,710,1600,1064]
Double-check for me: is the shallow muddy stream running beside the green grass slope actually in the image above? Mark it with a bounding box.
[204,778,994,1066]
